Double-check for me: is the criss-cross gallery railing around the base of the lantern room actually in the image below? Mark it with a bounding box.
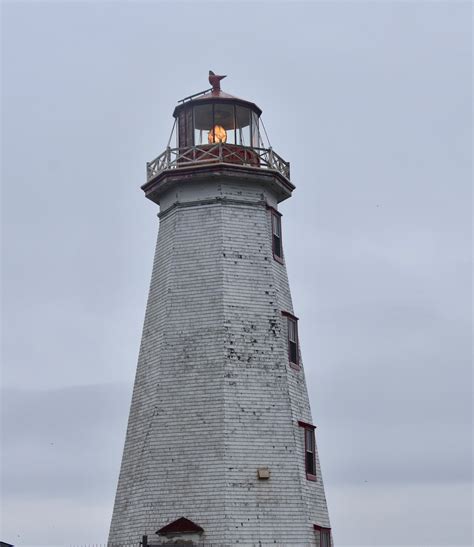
[147,143,290,181]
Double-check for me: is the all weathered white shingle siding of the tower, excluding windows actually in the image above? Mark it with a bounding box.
[109,180,329,546]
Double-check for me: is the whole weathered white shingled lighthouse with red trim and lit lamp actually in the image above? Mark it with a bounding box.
[109,72,333,547]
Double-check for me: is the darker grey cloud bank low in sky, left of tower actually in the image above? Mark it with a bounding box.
[2,384,131,505]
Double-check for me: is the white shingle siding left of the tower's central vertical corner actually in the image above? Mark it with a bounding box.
[110,203,224,542]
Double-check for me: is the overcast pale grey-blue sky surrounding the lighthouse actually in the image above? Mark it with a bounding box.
[0,0,472,547]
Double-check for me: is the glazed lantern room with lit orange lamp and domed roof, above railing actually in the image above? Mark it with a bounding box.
[173,90,262,148]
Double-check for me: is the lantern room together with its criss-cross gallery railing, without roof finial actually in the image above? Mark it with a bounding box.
[147,90,290,182]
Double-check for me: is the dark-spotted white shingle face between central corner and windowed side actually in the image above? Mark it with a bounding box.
[223,204,308,544]
